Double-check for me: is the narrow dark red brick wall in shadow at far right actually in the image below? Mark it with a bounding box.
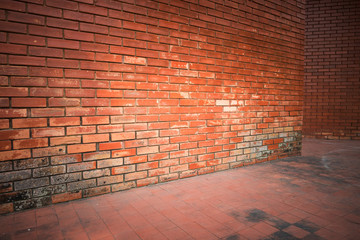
[303,0,360,139]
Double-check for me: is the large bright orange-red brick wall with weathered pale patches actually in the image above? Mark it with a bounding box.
[0,0,305,213]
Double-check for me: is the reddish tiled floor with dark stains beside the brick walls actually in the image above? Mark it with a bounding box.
[0,139,360,240]
